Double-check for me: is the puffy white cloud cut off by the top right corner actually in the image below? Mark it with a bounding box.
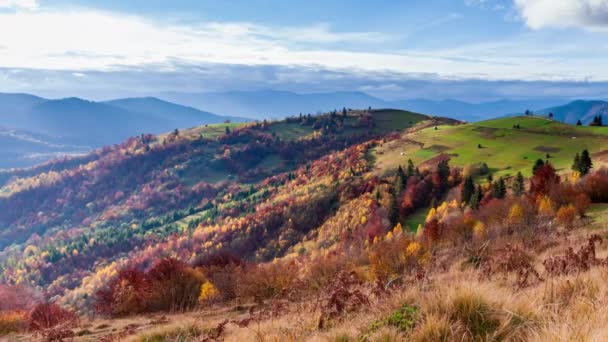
[514,0,608,30]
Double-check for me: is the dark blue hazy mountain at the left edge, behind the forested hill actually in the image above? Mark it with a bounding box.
[0,94,246,168]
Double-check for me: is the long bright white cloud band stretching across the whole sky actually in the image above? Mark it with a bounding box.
[0,7,608,79]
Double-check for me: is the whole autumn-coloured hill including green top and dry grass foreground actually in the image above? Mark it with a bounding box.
[0,109,608,341]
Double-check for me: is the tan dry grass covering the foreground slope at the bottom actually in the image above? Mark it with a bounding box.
[10,220,608,342]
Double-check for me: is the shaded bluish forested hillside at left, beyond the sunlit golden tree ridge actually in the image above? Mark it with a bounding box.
[0,110,433,300]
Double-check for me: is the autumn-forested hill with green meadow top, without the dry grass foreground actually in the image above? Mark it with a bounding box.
[0,110,608,336]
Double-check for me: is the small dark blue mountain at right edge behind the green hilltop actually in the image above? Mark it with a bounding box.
[535,100,608,125]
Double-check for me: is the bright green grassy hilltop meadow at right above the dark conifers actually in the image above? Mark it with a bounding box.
[376,117,608,176]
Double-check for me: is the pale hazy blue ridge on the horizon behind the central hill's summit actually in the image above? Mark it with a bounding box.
[159,90,565,121]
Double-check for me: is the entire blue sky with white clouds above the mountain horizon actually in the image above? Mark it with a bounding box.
[0,0,608,101]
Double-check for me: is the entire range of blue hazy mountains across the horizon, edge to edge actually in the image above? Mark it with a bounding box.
[0,90,608,168]
